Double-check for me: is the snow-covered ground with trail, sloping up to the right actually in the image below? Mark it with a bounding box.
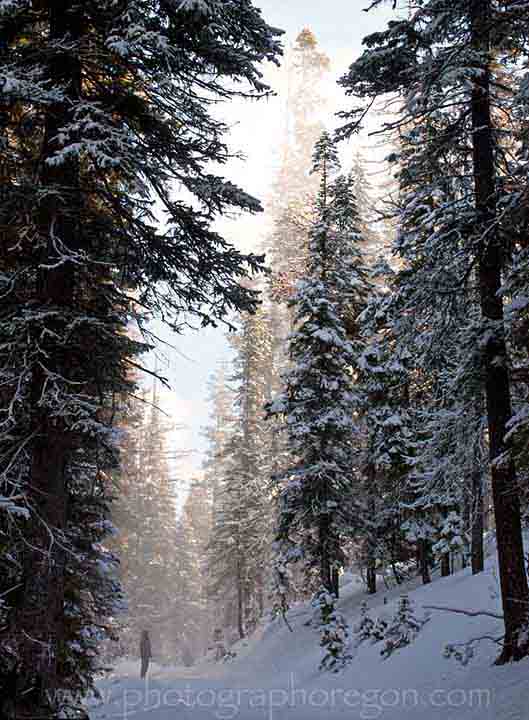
[90,560,529,720]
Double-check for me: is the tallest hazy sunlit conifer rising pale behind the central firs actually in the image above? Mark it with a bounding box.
[255,35,330,604]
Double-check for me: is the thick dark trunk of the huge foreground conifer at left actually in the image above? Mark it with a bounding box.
[16,0,81,715]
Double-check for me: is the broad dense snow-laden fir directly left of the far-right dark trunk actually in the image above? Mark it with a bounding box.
[384,113,488,580]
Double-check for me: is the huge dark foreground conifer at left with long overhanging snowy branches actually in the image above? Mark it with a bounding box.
[0,0,280,715]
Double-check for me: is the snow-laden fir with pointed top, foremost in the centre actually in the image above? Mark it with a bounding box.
[269,133,369,640]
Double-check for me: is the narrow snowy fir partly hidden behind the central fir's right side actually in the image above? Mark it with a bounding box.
[320,170,394,592]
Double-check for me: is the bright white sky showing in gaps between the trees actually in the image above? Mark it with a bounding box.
[148,0,392,498]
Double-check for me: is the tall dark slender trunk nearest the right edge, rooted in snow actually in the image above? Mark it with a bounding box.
[470,0,529,663]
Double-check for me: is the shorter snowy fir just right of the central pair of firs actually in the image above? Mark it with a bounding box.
[358,276,415,594]
